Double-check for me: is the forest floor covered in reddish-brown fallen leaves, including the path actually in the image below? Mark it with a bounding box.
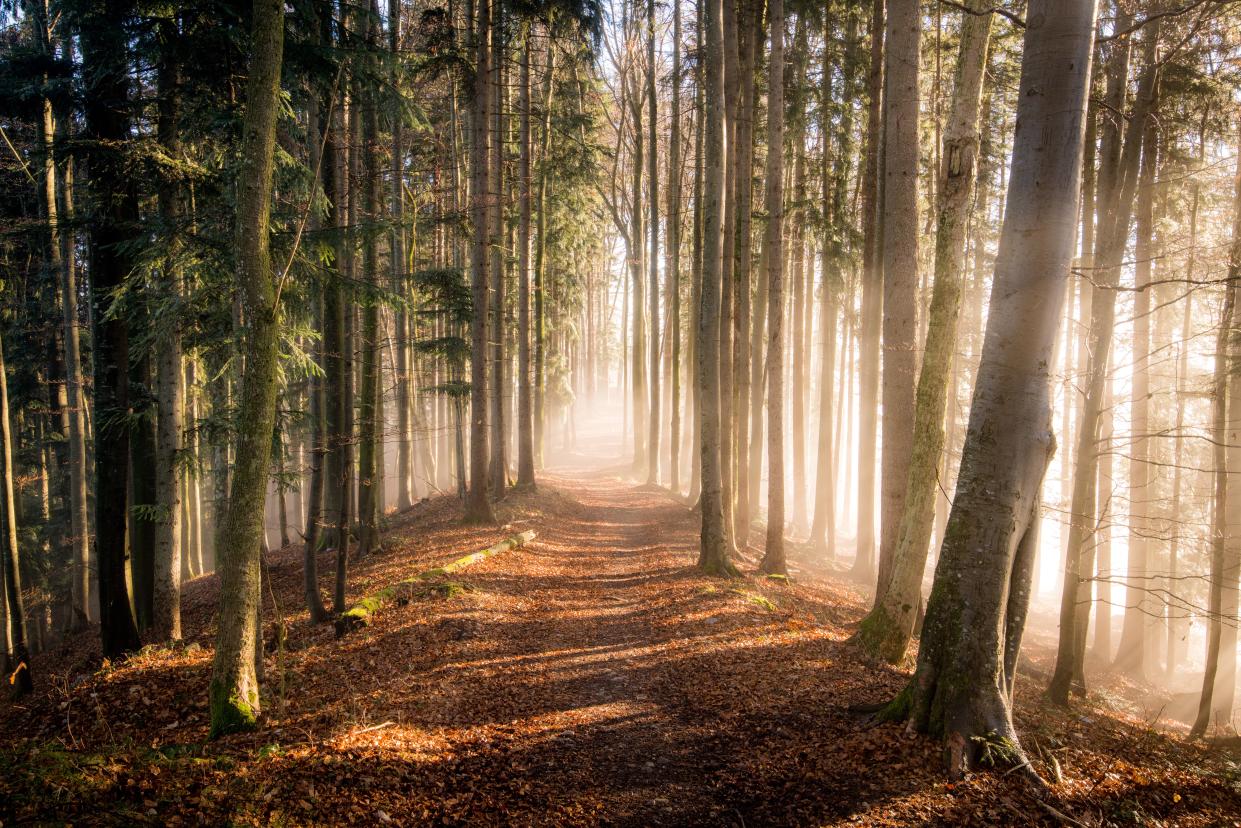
[0,434,1241,827]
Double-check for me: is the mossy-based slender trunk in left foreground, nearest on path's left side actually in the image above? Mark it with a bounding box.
[210,0,284,737]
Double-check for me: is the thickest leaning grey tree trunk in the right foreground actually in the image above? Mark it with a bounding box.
[881,0,1096,775]
